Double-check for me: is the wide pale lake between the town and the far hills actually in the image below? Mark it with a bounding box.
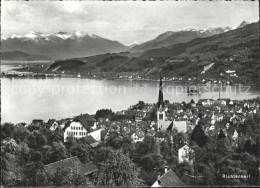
[1,65,259,123]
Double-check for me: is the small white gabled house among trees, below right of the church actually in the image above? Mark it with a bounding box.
[178,144,195,165]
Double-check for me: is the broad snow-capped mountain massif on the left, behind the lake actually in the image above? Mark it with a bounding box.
[1,31,128,59]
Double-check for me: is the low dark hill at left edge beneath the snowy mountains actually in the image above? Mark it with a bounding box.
[1,51,50,61]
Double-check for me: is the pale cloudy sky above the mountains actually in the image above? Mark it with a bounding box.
[1,1,259,45]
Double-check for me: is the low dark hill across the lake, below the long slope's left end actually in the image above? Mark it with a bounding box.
[48,53,157,75]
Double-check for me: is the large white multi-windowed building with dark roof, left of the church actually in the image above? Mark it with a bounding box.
[64,114,101,142]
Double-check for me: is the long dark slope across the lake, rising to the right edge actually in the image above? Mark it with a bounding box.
[47,23,260,84]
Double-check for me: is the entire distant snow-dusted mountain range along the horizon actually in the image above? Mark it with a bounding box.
[1,22,248,60]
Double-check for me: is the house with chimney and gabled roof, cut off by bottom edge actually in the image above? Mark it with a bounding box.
[151,168,184,187]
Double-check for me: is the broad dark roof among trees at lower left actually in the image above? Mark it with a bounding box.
[43,156,98,175]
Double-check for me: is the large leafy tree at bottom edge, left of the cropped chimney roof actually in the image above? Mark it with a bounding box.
[95,151,142,186]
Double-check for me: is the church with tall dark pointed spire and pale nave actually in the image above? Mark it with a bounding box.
[157,77,188,132]
